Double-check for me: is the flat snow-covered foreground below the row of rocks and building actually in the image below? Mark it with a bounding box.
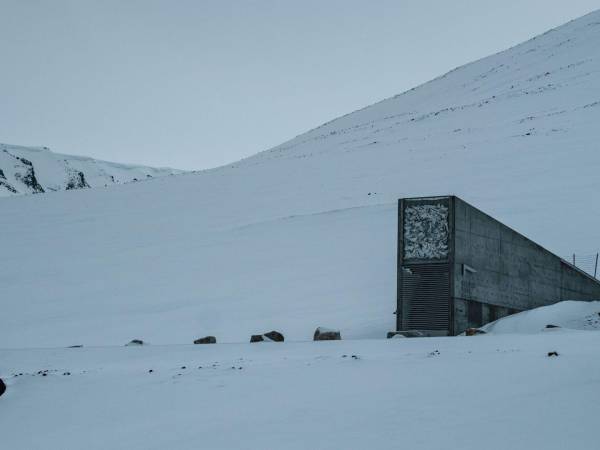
[0,330,600,450]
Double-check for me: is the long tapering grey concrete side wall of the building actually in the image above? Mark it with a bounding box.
[451,197,600,334]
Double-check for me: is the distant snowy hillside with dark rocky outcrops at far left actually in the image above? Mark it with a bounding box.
[0,144,182,197]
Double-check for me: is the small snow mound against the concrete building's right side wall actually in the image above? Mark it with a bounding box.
[482,301,600,334]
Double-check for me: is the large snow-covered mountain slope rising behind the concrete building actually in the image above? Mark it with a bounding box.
[0,12,600,347]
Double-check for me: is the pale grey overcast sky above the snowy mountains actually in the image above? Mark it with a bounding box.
[0,0,600,169]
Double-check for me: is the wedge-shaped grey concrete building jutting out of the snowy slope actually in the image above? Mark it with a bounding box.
[396,196,600,336]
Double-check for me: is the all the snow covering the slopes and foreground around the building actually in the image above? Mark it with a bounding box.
[0,8,600,450]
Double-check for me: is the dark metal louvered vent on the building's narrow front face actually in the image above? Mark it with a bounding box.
[401,263,450,331]
